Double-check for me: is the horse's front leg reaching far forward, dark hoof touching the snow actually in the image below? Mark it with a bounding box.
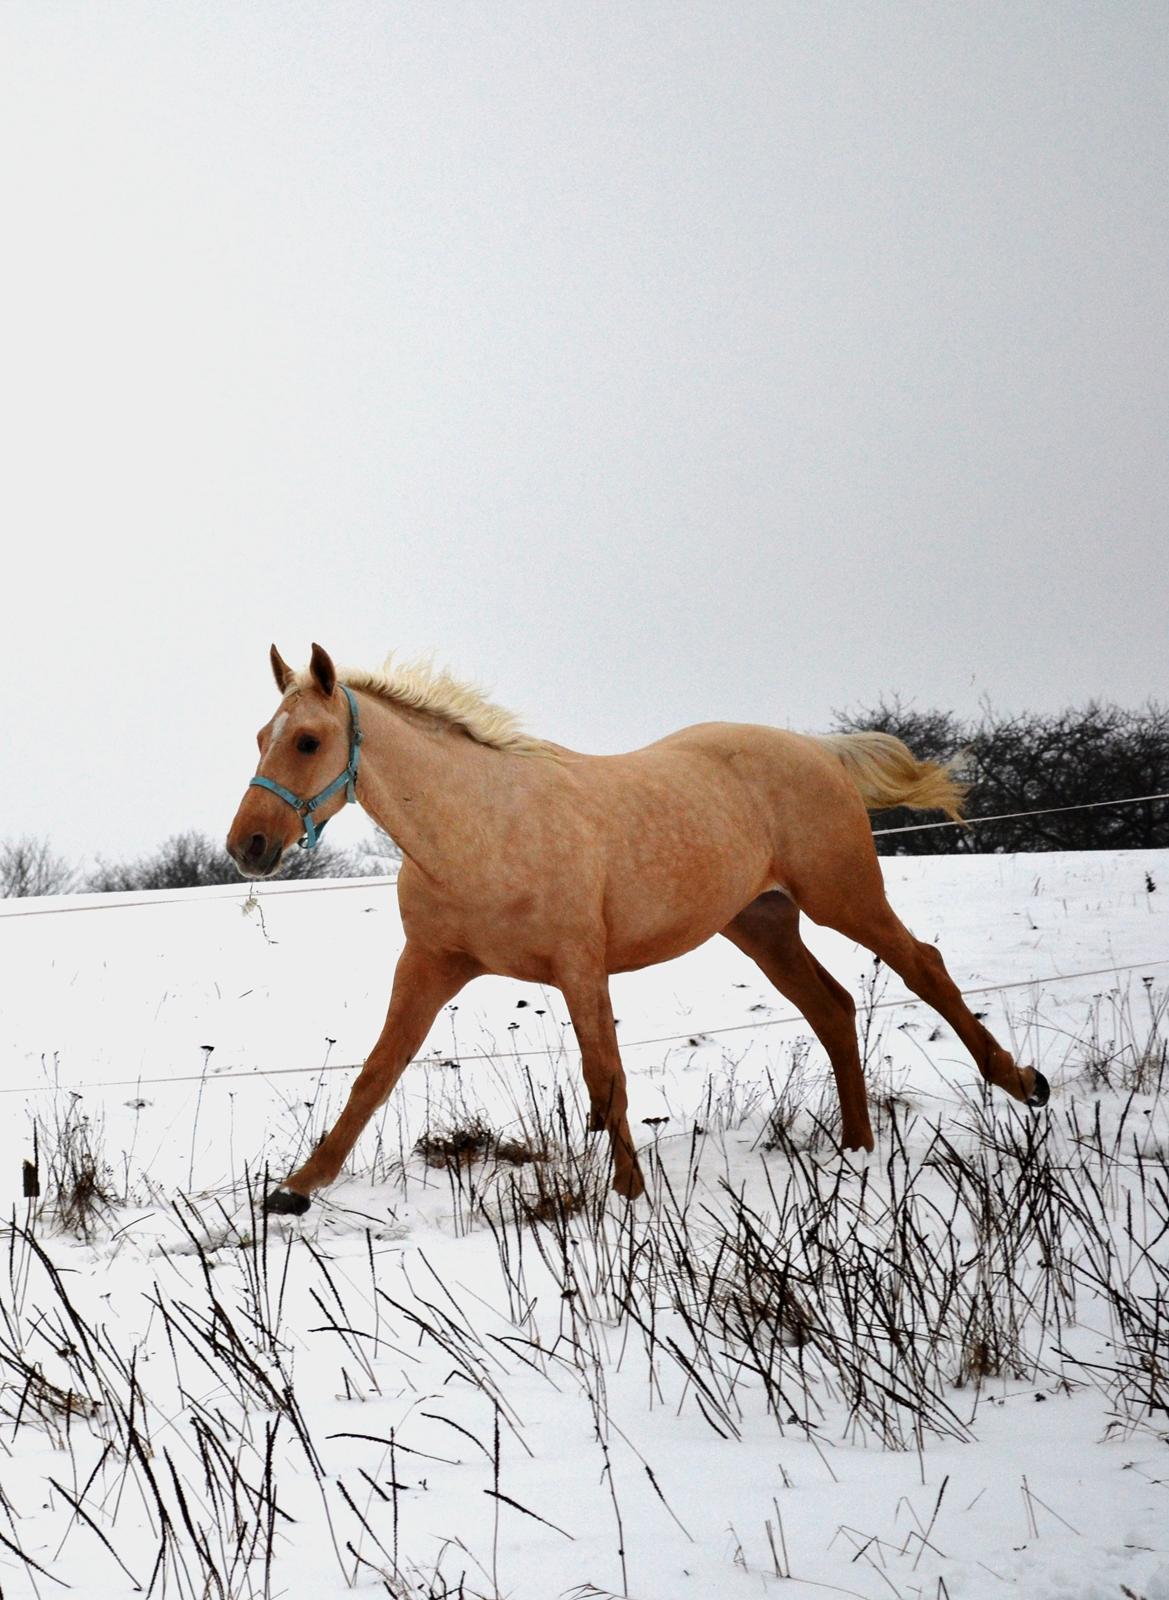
[264,944,478,1214]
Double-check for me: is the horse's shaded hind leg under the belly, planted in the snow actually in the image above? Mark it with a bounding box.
[723,890,873,1150]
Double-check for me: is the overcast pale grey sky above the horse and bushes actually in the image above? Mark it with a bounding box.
[0,0,1169,876]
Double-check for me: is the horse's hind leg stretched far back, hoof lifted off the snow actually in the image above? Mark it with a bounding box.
[809,890,1049,1106]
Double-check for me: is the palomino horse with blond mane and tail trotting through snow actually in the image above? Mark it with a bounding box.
[227,645,1047,1213]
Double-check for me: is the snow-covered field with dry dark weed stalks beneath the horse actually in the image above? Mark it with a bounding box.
[0,851,1169,1600]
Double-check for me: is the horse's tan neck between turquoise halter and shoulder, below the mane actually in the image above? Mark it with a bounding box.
[357,694,497,877]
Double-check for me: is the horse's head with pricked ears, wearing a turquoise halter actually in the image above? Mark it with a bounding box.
[227,645,361,878]
